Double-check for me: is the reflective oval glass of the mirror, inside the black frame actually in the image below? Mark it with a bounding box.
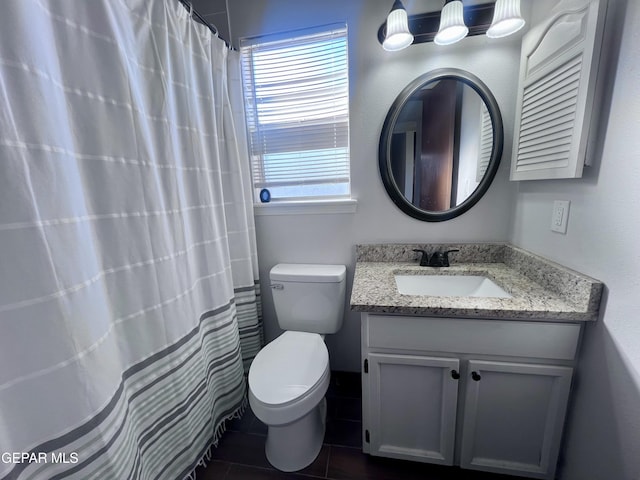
[390,79,493,212]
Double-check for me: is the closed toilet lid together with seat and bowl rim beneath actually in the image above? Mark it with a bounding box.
[249,331,330,425]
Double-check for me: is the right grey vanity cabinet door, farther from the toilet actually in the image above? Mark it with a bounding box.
[460,360,572,479]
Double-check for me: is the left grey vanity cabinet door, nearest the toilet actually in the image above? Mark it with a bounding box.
[368,354,460,465]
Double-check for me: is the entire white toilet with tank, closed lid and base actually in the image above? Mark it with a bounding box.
[249,264,346,472]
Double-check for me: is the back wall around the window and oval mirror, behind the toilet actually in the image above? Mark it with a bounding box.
[228,0,519,371]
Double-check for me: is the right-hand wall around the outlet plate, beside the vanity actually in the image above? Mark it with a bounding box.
[511,0,640,480]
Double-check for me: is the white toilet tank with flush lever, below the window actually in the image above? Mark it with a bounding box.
[269,263,347,334]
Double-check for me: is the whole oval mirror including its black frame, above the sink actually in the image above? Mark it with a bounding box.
[378,69,503,222]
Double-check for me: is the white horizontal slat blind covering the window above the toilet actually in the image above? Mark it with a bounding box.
[240,25,350,202]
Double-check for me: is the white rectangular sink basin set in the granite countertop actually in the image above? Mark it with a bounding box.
[395,274,511,298]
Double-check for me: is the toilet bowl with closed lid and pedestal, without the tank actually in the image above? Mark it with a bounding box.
[249,331,330,472]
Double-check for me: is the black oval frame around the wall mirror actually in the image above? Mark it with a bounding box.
[378,68,504,222]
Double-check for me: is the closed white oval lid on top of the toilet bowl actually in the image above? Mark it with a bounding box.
[249,331,329,405]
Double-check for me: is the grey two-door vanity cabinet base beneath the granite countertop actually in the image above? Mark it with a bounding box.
[362,313,581,479]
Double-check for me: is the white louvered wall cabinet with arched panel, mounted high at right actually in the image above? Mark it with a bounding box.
[511,0,607,180]
